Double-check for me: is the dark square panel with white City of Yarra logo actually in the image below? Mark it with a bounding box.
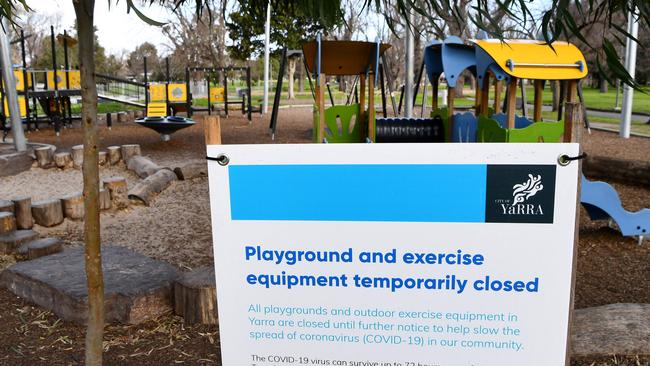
[485,165,556,224]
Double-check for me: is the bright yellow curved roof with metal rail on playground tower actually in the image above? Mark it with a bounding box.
[472,39,587,80]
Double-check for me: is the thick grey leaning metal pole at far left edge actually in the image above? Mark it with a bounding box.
[0,17,27,151]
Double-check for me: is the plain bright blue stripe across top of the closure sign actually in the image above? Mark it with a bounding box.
[228,165,487,222]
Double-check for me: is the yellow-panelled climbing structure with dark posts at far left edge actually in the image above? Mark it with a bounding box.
[0,26,81,140]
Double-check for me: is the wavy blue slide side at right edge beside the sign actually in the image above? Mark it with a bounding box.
[580,175,650,243]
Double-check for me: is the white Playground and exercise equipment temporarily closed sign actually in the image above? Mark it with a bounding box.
[208,144,578,366]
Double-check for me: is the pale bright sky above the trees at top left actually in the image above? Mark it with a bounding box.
[27,0,170,54]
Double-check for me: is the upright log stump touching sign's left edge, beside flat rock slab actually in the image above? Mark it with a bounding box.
[174,266,218,325]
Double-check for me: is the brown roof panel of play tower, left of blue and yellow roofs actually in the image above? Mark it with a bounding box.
[302,41,390,75]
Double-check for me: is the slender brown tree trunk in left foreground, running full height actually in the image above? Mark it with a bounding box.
[72,0,104,366]
